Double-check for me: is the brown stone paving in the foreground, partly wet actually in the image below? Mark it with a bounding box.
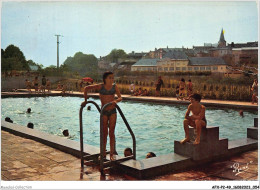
[1,130,258,181]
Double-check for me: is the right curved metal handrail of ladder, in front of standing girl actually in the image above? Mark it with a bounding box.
[100,102,136,171]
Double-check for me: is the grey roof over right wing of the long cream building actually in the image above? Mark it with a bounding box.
[189,57,227,66]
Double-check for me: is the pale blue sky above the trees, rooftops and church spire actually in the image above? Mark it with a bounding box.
[1,1,259,67]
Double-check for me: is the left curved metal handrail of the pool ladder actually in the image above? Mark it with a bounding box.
[79,101,101,167]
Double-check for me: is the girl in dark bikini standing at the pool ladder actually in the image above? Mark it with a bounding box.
[81,71,122,160]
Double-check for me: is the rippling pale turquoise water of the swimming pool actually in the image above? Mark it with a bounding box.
[1,97,257,159]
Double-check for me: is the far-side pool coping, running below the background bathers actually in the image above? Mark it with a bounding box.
[1,89,258,111]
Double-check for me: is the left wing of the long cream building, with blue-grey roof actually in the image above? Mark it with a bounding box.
[131,58,158,71]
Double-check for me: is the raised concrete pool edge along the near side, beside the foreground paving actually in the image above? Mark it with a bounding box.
[1,120,258,179]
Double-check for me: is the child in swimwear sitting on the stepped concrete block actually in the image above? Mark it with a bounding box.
[180,94,207,145]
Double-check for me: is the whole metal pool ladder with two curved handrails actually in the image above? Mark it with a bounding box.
[79,101,136,172]
